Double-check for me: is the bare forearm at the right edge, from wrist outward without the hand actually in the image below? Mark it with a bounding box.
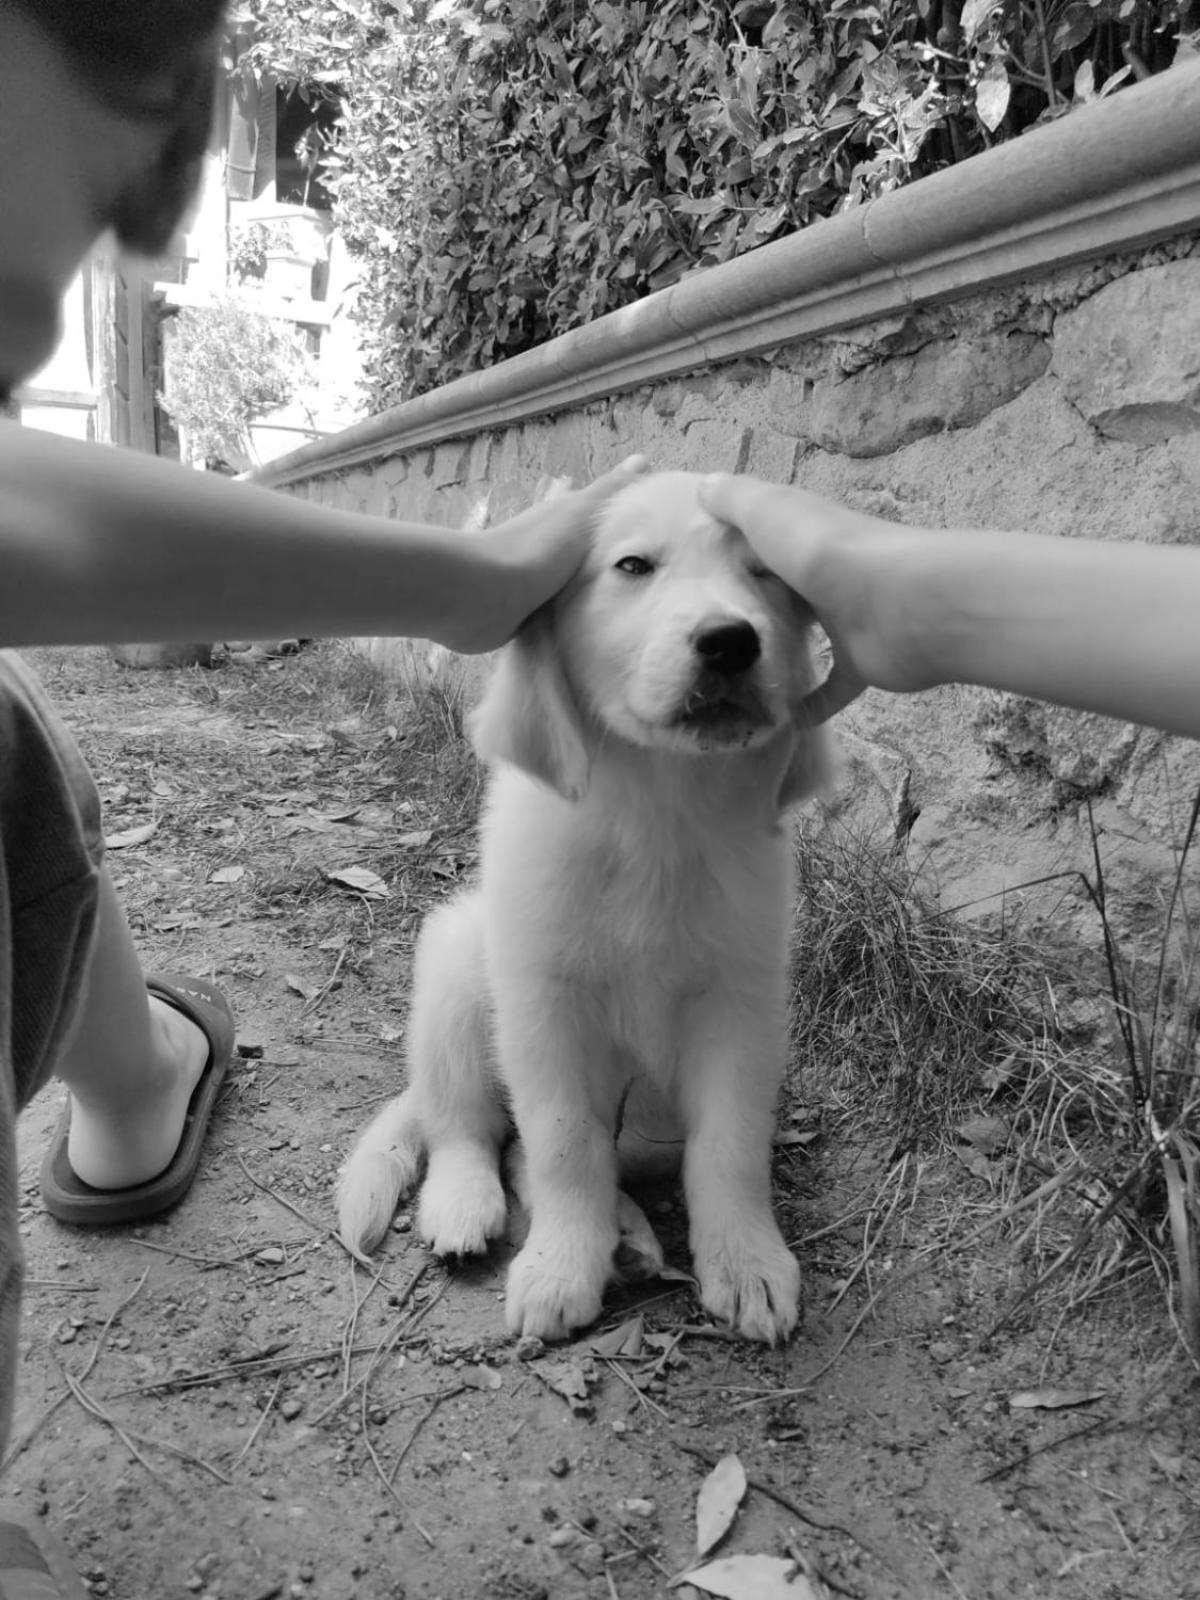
[893,531,1200,738]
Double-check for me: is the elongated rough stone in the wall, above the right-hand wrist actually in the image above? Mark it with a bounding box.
[810,333,1050,456]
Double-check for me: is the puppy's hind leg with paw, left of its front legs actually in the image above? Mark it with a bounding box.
[408,894,509,1256]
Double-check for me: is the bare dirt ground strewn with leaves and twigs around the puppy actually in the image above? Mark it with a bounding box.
[3,646,1200,1600]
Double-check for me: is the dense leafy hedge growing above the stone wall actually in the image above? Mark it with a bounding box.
[230,0,1200,405]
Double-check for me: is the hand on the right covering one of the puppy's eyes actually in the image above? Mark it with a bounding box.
[701,472,936,722]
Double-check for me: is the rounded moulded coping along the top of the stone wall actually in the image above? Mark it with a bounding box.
[254,61,1200,488]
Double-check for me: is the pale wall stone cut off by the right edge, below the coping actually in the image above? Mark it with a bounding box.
[1051,259,1200,445]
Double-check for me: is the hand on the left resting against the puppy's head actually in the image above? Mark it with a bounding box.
[454,456,650,654]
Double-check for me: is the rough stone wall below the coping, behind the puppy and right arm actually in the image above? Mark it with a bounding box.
[284,237,1200,925]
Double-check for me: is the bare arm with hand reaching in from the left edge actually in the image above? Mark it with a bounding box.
[0,424,640,651]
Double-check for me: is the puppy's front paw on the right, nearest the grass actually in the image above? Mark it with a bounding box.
[693,1221,800,1344]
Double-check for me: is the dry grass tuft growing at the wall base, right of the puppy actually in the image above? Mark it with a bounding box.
[792,797,1200,1355]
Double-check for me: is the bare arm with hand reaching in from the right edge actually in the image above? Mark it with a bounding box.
[704,477,1200,738]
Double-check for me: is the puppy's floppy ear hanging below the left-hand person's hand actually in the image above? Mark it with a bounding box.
[470,605,592,800]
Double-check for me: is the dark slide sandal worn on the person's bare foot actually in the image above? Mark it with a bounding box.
[39,973,234,1222]
